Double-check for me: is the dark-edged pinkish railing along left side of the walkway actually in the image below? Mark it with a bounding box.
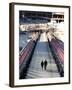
[19,32,40,79]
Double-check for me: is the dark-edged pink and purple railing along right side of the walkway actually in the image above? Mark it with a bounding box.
[48,38,64,77]
